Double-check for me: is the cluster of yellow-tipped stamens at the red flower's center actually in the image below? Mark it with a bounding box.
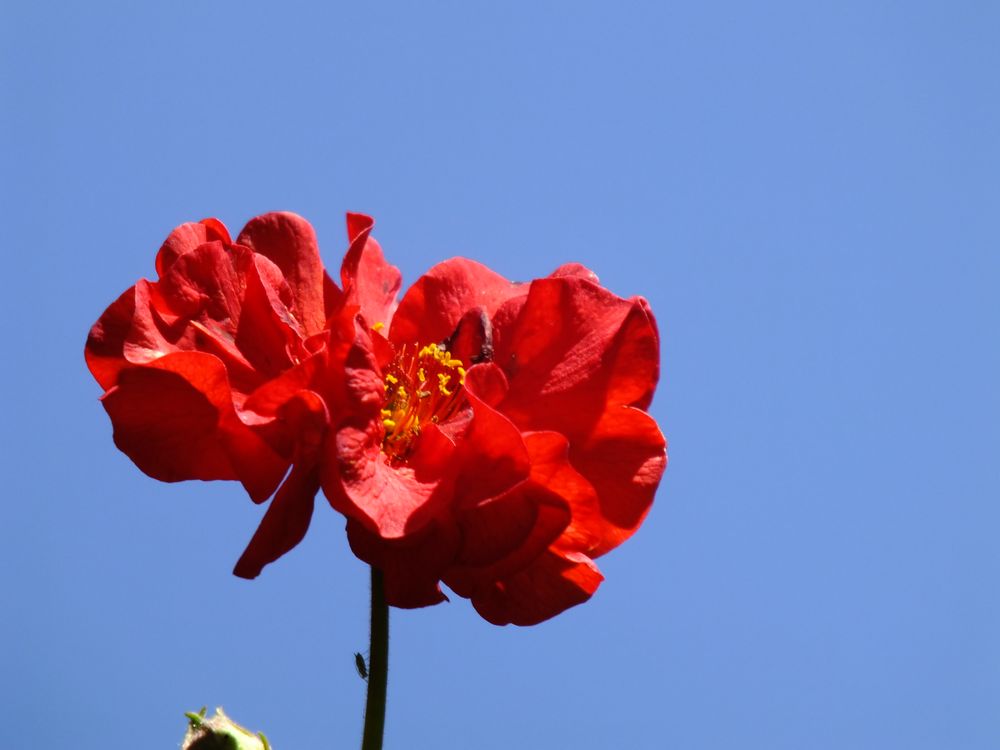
[382,344,465,461]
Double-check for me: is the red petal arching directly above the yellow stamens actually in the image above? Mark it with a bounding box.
[389,258,524,344]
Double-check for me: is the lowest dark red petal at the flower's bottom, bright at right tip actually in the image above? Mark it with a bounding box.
[472,552,604,625]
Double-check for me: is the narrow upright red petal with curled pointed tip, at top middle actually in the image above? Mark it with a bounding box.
[340,214,403,326]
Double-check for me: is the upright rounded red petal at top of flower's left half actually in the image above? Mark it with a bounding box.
[236,212,341,334]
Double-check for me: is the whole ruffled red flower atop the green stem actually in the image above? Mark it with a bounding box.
[86,213,666,625]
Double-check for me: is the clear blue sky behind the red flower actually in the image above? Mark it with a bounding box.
[0,0,1000,750]
